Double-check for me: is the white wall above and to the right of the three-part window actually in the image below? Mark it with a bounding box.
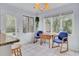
[39,4,79,51]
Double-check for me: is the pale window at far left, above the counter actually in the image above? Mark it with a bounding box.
[6,15,16,34]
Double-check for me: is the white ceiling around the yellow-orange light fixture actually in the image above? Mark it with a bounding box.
[11,3,66,14]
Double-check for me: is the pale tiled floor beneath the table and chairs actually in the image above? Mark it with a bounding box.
[22,43,79,56]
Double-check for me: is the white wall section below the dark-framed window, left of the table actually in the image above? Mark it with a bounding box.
[17,33,34,44]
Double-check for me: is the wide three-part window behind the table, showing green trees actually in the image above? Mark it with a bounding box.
[45,14,73,34]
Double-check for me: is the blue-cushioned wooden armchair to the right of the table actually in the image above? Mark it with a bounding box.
[52,32,68,53]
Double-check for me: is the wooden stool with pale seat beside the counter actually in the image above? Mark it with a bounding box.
[12,44,22,56]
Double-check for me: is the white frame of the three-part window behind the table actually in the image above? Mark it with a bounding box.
[44,13,74,35]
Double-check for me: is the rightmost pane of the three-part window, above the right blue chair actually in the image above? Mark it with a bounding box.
[62,14,73,34]
